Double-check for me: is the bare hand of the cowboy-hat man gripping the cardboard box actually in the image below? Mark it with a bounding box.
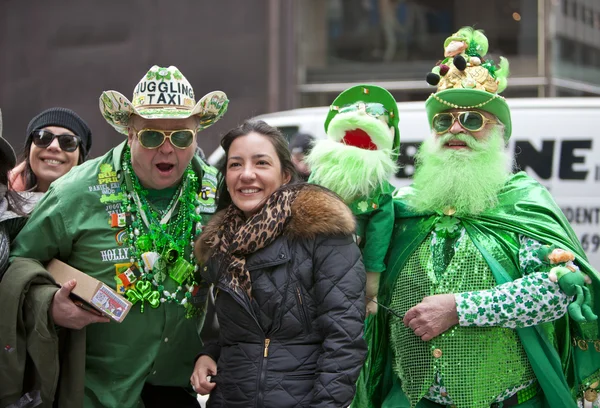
[50,279,110,330]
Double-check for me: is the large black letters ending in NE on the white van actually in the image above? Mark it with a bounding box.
[396,139,600,182]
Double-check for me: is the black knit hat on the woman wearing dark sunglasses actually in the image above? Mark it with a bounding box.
[26,108,92,157]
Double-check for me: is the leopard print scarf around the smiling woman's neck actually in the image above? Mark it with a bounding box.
[207,185,302,299]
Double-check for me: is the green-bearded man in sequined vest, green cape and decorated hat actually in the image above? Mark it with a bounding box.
[353,28,600,408]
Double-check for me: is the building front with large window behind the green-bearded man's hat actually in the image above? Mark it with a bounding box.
[297,0,600,106]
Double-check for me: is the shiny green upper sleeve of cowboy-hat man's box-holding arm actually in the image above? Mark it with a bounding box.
[10,186,72,263]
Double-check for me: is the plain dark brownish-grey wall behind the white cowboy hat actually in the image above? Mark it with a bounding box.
[0,0,274,161]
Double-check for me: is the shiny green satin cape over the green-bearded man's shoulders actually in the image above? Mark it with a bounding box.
[353,172,600,408]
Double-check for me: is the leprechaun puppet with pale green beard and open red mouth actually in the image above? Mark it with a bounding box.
[307,85,400,315]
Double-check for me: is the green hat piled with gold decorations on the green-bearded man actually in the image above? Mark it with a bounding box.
[425,27,512,141]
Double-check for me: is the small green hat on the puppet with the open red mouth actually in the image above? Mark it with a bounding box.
[325,85,400,150]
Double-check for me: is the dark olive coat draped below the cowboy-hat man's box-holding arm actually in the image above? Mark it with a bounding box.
[0,258,85,408]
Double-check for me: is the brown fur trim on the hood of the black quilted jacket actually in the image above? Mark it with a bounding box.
[194,184,356,263]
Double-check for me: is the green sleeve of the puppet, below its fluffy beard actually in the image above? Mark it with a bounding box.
[362,194,394,272]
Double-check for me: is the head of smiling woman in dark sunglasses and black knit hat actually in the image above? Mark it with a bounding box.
[10,107,92,193]
